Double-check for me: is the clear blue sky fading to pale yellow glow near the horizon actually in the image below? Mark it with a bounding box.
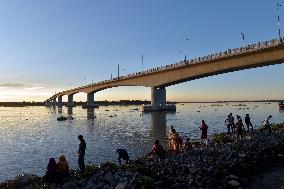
[0,0,284,101]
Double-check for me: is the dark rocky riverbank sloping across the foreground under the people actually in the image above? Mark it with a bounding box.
[0,123,284,189]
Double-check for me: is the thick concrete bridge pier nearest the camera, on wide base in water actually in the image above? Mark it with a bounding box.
[143,87,176,112]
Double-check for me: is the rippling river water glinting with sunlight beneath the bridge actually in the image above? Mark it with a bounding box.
[0,103,284,181]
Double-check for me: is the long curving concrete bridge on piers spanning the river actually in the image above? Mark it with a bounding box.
[45,37,284,111]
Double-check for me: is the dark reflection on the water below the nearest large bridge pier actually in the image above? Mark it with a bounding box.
[149,112,167,145]
